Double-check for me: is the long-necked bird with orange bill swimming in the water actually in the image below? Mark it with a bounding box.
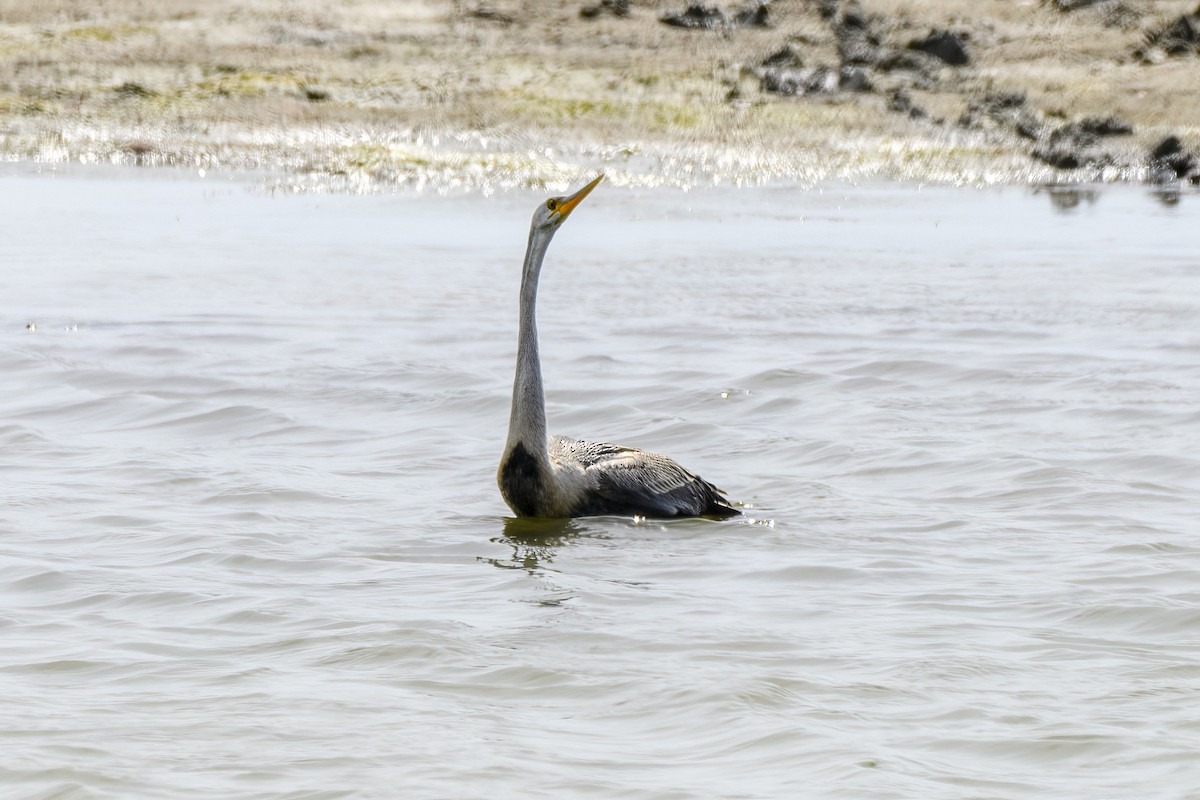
[496,174,740,518]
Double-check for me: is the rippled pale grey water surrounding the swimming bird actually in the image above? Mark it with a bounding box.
[0,166,1200,800]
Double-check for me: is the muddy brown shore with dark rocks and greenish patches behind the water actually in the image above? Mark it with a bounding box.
[0,0,1200,192]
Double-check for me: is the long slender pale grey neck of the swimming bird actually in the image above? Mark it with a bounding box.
[505,228,550,458]
